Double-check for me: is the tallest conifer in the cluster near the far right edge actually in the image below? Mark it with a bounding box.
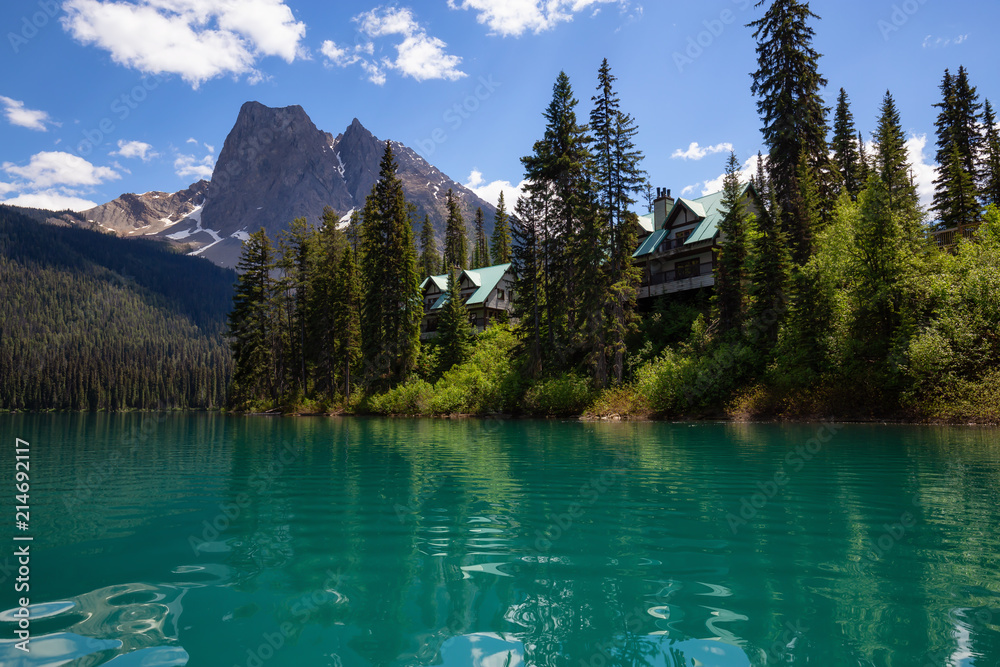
[933,67,982,228]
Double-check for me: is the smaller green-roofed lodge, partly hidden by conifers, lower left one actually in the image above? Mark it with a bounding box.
[420,263,514,340]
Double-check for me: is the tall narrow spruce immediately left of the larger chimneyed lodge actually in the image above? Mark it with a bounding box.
[580,58,648,385]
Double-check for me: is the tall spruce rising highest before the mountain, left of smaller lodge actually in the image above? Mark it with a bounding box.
[361,142,423,388]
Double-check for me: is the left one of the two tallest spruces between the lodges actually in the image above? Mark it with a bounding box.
[521,72,591,367]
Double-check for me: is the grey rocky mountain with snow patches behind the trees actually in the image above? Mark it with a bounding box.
[50,102,496,267]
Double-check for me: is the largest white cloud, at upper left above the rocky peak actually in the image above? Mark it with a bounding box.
[62,0,306,88]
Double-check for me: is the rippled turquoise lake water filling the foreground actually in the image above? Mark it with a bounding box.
[0,414,1000,667]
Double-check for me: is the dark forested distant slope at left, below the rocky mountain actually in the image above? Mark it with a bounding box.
[0,206,236,410]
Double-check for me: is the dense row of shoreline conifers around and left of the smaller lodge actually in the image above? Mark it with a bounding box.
[228,149,511,409]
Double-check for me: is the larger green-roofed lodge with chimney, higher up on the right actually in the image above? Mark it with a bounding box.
[632,184,760,305]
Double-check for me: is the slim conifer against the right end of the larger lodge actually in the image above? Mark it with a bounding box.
[714,152,747,333]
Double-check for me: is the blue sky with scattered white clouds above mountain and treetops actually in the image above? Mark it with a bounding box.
[0,0,1000,214]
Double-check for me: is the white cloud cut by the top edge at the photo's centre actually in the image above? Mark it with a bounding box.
[448,0,629,37]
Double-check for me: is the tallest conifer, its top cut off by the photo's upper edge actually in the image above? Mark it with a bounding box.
[750,0,835,265]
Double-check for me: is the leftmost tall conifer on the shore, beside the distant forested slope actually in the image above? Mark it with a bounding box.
[229,229,277,407]
